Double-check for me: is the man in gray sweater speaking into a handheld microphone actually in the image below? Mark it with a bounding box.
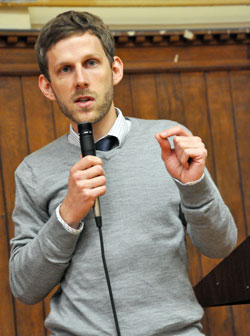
[10,12,237,336]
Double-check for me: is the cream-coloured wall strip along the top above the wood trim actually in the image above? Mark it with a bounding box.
[0,5,250,29]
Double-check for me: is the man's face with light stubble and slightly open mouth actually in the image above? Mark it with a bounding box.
[42,32,121,128]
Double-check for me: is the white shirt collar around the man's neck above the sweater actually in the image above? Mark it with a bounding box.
[68,107,131,147]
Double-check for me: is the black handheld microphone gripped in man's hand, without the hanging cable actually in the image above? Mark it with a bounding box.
[78,123,102,227]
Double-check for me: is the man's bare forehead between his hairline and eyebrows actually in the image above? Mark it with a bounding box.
[47,32,105,63]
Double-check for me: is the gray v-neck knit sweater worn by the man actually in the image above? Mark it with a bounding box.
[10,118,237,336]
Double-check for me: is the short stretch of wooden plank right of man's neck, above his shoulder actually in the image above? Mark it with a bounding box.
[114,74,134,117]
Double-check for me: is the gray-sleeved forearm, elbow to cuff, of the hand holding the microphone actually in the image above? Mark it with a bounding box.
[10,213,79,304]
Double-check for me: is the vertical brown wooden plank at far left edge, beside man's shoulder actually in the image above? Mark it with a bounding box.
[0,77,28,236]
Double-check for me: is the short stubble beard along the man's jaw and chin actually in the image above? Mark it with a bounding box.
[54,84,114,124]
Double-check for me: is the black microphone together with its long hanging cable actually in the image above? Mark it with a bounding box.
[78,123,121,336]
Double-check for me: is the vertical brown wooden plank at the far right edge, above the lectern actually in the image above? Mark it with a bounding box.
[230,70,250,236]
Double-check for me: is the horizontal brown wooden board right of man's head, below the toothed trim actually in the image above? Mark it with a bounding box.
[116,42,249,73]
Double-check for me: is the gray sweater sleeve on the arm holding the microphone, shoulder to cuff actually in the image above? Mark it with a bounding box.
[9,162,79,304]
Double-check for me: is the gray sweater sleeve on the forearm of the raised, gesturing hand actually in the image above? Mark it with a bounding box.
[176,170,237,258]
